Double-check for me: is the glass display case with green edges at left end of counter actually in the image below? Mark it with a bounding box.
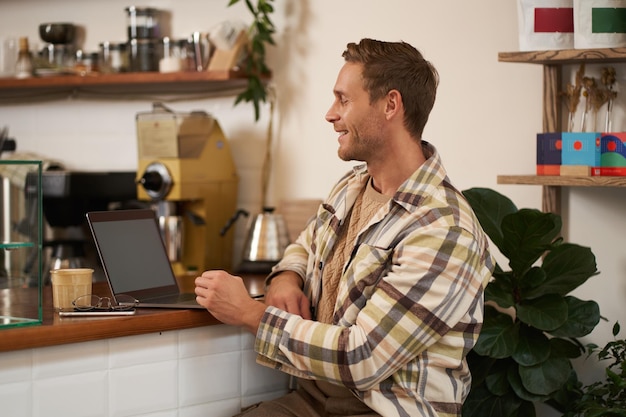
[0,160,43,329]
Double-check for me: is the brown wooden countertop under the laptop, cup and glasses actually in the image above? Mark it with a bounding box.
[0,276,263,352]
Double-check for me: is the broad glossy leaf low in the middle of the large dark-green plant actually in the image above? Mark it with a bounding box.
[519,357,572,395]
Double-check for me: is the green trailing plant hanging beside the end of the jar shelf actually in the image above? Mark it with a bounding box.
[228,0,276,121]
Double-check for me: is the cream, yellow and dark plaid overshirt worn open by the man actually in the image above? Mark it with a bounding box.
[255,142,493,417]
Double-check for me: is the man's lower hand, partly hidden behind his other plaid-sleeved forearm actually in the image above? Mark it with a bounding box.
[265,271,311,320]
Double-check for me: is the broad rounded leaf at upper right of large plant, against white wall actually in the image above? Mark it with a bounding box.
[524,243,598,298]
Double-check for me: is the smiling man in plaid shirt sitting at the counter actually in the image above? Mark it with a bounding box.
[196,39,493,417]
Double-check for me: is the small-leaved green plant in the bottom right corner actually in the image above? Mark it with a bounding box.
[564,323,626,417]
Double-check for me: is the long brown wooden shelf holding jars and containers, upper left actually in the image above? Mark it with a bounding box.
[0,71,256,100]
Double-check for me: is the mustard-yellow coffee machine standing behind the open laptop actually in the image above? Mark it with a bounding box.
[136,103,239,277]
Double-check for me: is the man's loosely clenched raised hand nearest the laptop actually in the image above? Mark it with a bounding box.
[195,271,265,334]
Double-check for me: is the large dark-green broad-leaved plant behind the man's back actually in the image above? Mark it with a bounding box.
[463,188,600,417]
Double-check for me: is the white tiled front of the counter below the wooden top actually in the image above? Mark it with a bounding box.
[0,325,288,417]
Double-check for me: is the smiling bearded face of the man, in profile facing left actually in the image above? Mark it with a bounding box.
[326,62,384,162]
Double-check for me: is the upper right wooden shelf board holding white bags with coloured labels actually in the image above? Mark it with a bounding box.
[498,48,626,65]
